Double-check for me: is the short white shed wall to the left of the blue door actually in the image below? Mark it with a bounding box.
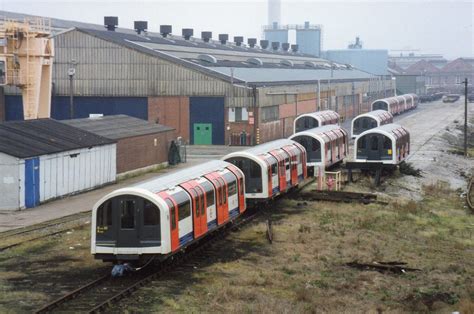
[0,153,25,210]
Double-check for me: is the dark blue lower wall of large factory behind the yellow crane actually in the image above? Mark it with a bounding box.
[5,95,148,121]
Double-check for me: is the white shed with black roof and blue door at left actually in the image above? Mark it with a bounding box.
[0,119,116,210]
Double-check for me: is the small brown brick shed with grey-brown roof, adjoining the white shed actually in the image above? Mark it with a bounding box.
[62,115,176,175]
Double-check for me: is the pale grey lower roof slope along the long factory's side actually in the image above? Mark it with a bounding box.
[208,67,373,83]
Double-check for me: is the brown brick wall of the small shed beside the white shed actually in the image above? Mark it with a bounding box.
[117,130,176,173]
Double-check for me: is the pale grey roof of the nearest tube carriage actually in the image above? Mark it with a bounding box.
[133,160,231,193]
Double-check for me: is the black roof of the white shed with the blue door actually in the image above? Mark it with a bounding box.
[0,119,115,158]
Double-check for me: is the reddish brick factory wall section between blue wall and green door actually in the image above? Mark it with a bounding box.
[148,96,190,141]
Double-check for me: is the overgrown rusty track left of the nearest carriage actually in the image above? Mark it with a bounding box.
[0,211,90,252]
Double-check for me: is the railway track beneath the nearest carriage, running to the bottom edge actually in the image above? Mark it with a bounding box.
[35,208,265,313]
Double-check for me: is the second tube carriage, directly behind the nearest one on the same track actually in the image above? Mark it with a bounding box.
[223,139,307,201]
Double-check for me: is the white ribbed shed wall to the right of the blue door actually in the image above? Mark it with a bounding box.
[39,144,117,202]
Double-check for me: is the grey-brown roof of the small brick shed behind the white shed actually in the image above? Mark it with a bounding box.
[61,115,174,140]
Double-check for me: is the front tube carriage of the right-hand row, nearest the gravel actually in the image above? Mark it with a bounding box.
[354,123,410,165]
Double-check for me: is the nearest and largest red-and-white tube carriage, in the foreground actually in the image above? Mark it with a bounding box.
[91,160,246,261]
